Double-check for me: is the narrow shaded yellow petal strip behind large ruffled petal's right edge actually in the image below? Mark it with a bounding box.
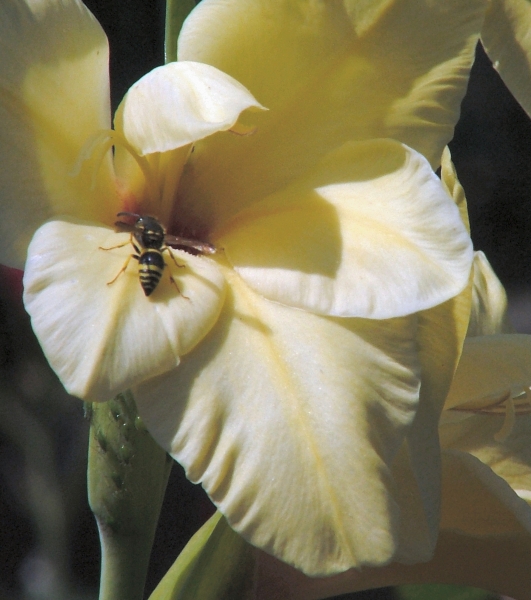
[393,286,471,563]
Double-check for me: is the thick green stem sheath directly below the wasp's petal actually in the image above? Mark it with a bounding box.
[88,392,173,600]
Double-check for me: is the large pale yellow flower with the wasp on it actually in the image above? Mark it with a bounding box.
[0,0,485,575]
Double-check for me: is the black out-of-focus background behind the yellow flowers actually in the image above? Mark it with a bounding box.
[0,0,531,600]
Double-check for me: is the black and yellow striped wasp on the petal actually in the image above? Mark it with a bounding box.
[100,212,216,296]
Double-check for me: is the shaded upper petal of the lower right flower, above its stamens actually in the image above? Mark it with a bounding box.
[445,334,531,410]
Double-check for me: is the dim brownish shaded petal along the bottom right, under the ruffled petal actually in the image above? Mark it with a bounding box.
[247,452,531,600]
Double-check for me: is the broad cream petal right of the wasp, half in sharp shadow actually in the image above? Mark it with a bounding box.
[218,140,472,319]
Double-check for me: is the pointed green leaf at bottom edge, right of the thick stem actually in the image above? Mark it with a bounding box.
[149,512,254,600]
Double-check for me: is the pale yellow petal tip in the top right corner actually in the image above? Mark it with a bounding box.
[481,0,531,115]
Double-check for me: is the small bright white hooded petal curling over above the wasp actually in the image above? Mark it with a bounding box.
[115,62,264,154]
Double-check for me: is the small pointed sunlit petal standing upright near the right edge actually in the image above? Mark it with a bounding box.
[467,251,512,336]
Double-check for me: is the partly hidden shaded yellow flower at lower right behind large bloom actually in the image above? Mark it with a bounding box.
[229,171,531,600]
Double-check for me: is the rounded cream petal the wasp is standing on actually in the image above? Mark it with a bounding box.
[24,221,224,401]
